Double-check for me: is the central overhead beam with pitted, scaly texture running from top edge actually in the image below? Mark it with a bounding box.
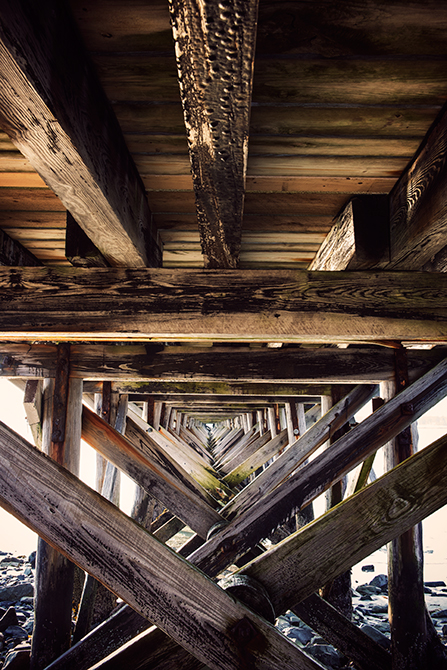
[169,0,258,268]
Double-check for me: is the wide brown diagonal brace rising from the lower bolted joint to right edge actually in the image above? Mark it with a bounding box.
[241,430,447,612]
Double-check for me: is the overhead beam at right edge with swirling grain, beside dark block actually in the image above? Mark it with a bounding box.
[387,106,447,270]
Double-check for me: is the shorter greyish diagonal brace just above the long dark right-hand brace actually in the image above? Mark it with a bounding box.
[222,386,376,519]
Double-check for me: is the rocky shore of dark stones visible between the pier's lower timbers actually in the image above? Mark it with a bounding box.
[0,550,447,670]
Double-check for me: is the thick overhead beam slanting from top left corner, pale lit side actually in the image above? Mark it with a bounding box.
[0,0,161,267]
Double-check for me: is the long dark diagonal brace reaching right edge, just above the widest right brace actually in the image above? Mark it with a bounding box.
[190,360,447,575]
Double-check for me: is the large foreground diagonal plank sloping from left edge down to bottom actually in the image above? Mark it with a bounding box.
[0,424,326,670]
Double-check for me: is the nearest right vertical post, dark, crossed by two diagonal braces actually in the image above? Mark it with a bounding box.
[384,347,430,670]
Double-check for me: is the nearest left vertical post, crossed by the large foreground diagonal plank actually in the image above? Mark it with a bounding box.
[30,344,82,670]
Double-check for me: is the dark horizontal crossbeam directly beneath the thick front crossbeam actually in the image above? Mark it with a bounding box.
[0,342,447,386]
